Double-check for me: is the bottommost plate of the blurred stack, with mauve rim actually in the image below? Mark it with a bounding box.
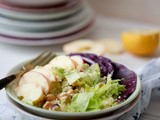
[0,19,94,46]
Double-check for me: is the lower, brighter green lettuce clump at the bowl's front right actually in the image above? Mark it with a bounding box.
[67,74,125,112]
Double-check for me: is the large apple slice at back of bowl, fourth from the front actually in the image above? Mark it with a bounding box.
[49,55,75,70]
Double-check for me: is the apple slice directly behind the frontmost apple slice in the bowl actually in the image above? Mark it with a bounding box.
[19,71,51,94]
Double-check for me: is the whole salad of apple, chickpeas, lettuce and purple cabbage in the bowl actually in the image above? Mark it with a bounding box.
[6,53,140,118]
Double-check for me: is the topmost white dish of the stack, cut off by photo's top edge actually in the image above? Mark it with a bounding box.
[2,0,66,7]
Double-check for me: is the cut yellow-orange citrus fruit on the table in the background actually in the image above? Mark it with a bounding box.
[121,31,159,56]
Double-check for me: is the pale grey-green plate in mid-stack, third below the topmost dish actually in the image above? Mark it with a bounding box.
[0,7,92,31]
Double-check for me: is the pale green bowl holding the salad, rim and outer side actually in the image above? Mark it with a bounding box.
[6,55,141,119]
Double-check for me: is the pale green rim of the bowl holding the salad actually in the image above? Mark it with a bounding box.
[5,57,141,117]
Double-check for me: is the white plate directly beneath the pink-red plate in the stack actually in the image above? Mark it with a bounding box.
[0,2,83,21]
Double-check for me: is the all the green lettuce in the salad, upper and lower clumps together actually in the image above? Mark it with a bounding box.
[53,63,125,112]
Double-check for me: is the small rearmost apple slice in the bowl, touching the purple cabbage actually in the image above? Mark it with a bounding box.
[70,56,84,70]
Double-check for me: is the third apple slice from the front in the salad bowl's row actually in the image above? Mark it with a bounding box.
[31,67,56,82]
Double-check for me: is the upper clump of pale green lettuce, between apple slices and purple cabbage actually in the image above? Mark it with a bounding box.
[52,64,101,86]
